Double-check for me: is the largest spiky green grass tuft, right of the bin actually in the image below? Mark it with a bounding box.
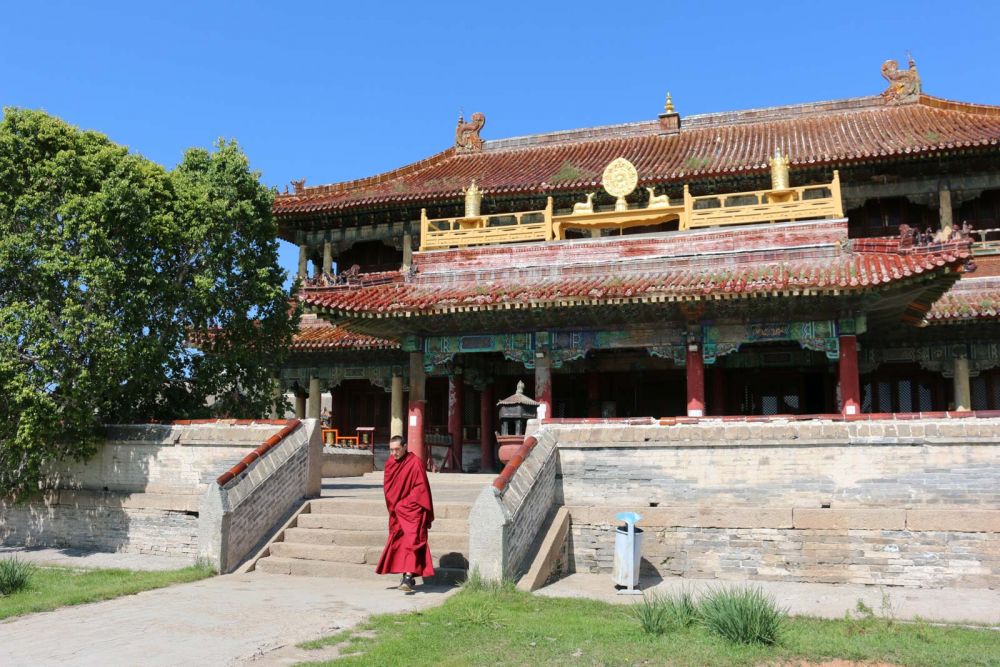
[698,588,787,645]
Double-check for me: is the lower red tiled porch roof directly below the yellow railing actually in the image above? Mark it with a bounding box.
[300,221,969,318]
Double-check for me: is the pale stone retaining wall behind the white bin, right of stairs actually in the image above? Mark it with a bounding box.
[556,419,1000,587]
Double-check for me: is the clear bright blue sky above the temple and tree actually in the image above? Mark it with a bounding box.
[0,1,1000,284]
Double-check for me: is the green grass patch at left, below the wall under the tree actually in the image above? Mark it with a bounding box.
[0,565,215,619]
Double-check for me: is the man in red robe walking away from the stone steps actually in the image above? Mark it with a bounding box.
[375,435,434,591]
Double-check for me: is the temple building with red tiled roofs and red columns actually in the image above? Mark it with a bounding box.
[274,61,1000,469]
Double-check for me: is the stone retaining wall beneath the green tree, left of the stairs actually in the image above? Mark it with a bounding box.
[0,420,318,558]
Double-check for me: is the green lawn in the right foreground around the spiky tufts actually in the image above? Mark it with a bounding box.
[296,587,1000,667]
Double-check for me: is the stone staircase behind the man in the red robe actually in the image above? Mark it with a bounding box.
[255,497,471,583]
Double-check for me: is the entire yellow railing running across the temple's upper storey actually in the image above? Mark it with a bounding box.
[420,171,844,250]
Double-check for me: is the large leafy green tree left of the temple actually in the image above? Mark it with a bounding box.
[0,109,298,493]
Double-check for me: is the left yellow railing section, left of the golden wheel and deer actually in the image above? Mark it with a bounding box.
[420,197,552,250]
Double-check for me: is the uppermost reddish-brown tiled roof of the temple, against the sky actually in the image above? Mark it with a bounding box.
[274,95,1000,216]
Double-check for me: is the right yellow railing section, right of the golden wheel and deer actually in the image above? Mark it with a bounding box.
[679,171,844,229]
